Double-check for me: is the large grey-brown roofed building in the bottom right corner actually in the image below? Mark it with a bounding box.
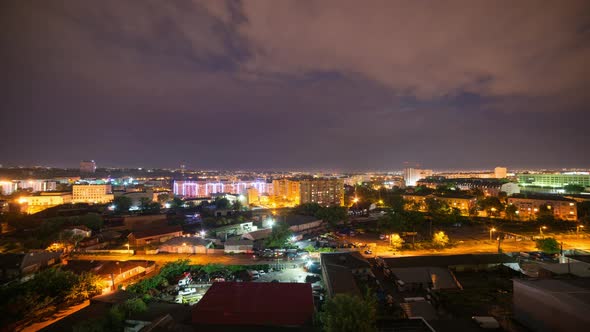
[512,278,590,332]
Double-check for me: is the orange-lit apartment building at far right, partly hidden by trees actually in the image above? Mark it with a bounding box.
[507,194,578,221]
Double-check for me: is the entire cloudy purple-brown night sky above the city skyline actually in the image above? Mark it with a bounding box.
[0,0,590,171]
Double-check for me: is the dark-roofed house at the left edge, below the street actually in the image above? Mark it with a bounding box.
[0,251,62,283]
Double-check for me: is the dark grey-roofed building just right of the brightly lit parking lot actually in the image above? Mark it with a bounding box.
[320,251,372,296]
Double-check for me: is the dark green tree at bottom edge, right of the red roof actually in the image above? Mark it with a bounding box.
[319,294,377,332]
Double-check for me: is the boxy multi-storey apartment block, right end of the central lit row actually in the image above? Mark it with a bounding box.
[300,179,344,206]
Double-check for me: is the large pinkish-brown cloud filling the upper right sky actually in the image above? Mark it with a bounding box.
[230,0,590,98]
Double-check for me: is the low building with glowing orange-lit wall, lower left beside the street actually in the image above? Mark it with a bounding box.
[64,260,156,293]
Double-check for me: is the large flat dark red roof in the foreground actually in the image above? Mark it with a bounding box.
[193,282,314,326]
